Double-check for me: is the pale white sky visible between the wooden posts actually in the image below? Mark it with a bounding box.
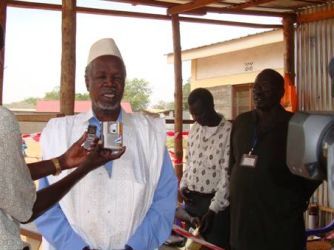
[4,0,280,106]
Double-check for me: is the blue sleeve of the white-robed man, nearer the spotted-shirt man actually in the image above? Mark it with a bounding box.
[127,149,177,250]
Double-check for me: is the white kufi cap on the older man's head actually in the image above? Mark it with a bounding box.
[87,38,123,65]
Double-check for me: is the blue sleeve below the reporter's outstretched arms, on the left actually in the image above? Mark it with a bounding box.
[35,178,87,250]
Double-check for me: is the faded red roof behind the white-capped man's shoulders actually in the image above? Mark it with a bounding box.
[36,100,132,113]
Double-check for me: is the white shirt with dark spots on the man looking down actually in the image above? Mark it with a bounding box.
[180,117,232,212]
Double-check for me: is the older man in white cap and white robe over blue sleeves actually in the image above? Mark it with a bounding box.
[36,38,177,250]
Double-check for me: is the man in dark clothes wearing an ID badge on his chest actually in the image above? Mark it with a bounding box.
[230,69,319,250]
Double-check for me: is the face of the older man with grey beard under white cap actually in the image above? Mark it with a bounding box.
[86,56,125,111]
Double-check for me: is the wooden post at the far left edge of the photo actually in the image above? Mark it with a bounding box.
[0,0,7,105]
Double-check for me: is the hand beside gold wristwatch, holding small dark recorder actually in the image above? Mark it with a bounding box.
[59,132,91,170]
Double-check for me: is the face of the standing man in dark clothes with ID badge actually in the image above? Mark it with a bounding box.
[253,81,283,111]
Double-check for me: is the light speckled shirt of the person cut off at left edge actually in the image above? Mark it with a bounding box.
[0,107,36,250]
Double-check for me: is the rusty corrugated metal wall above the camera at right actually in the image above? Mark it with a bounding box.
[295,2,334,111]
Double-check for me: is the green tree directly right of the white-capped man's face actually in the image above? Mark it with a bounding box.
[123,78,152,111]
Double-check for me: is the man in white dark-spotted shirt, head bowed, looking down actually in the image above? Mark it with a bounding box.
[180,88,231,247]
